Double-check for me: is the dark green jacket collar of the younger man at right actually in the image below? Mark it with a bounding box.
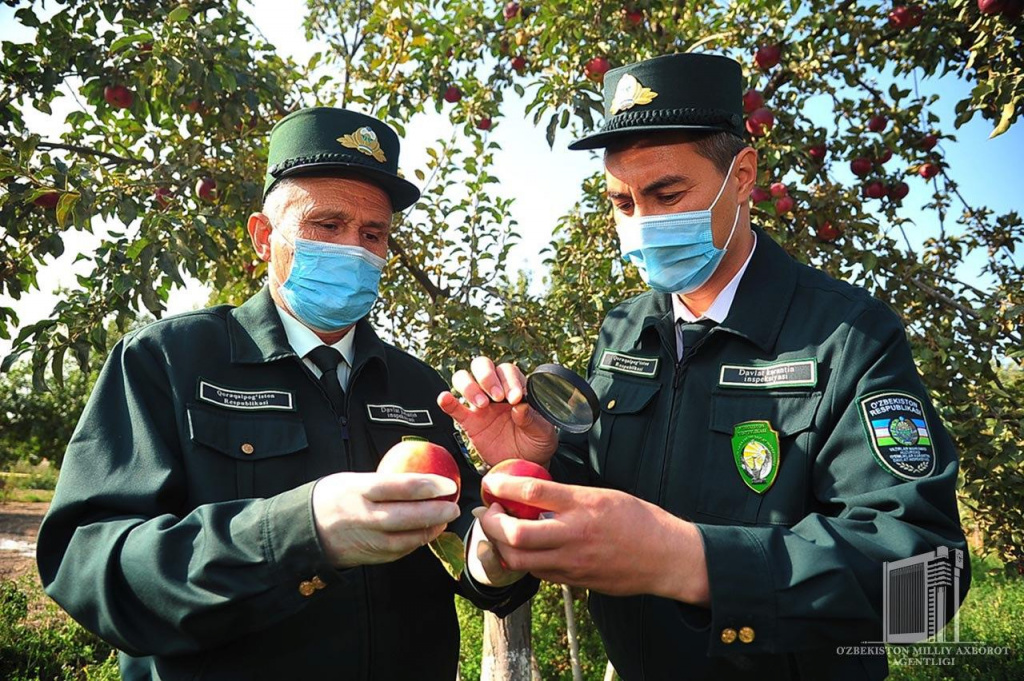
[636,227,799,352]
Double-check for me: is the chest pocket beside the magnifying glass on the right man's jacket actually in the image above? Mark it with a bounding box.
[590,373,662,493]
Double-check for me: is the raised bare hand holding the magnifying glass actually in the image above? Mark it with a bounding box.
[437,357,558,466]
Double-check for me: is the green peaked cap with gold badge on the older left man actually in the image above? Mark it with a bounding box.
[263,107,420,212]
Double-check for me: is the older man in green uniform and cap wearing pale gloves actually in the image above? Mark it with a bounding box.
[38,108,536,681]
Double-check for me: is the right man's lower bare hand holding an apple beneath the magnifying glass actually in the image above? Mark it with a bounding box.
[479,474,710,606]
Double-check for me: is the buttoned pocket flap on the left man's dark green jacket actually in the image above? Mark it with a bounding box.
[188,405,309,461]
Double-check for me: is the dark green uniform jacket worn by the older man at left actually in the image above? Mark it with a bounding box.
[38,289,537,681]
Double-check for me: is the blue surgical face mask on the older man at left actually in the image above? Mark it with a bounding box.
[270,231,385,333]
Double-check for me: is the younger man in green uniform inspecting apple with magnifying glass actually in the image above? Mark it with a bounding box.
[438,54,966,681]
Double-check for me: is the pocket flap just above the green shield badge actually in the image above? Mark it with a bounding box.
[711,392,821,437]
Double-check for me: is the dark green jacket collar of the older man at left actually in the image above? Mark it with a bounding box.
[227,287,387,374]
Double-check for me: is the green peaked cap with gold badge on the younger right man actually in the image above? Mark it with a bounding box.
[569,53,744,150]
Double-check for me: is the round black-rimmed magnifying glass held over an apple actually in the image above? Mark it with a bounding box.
[526,365,600,433]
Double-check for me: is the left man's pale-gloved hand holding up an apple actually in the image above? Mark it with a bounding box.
[312,473,460,567]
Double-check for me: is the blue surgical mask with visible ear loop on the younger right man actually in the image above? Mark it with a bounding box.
[616,158,740,294]
